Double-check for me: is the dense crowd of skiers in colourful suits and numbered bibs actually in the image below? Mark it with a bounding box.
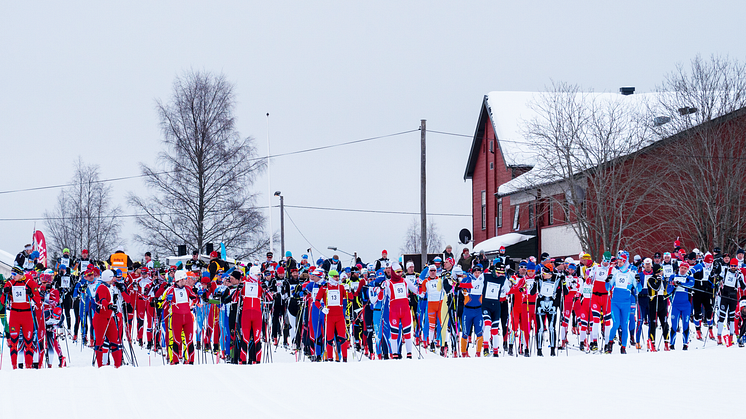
[0,241,746,368]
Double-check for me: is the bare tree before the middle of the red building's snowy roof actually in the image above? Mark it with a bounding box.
[524,83,659,258]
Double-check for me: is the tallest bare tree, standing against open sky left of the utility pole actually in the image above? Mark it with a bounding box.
[129,71,269,257]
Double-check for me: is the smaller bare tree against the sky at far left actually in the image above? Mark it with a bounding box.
[44,157,122,260]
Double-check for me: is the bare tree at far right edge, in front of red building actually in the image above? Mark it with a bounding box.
[651,56,746,251]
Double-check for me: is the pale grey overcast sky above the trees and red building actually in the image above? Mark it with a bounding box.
[0,0,746,266]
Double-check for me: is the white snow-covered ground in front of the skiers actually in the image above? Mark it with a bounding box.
[0,337,746,419]
